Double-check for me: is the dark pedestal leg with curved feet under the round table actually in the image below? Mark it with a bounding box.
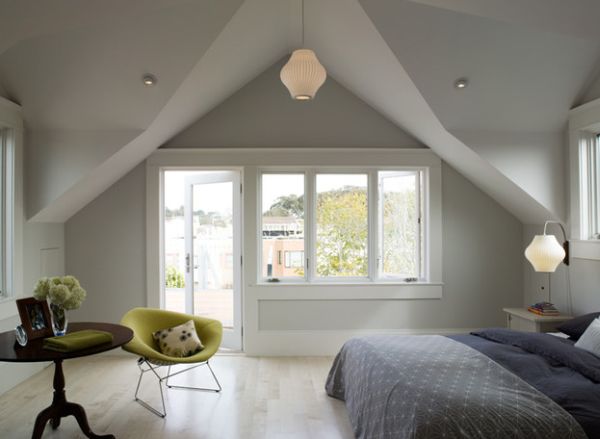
[31,360,115,439]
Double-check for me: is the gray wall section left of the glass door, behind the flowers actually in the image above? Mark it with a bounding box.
[65,163,146,323]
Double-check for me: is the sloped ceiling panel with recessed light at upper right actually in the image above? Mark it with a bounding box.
[362,0,600,132]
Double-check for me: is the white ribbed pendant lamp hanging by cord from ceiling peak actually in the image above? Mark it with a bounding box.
[279,0,327,101]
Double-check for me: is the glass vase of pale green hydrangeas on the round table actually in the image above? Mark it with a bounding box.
[33,276,86,335]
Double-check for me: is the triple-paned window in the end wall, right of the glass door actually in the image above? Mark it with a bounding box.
[259,168,428,282]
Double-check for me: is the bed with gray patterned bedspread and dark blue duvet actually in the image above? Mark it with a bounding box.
[325,329,600,439]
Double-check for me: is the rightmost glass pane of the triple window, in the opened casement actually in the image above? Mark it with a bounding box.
[379,171,421,278]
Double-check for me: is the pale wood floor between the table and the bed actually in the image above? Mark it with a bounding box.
[0,355,353,439]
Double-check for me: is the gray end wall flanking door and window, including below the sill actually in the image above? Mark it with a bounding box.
[66,160,523,336]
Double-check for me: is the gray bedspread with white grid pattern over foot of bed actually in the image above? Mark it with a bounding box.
[325,335,586,439]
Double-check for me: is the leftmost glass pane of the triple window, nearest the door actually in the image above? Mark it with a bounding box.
[261,174,304,279]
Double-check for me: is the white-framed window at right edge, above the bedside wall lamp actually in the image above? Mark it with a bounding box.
[579,134,600,239]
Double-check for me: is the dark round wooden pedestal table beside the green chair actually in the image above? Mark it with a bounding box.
[0,322,133,439]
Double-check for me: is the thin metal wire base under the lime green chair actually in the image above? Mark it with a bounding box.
[134,357,222,418]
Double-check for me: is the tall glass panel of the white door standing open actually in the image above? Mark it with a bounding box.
[192,181,234,328]
